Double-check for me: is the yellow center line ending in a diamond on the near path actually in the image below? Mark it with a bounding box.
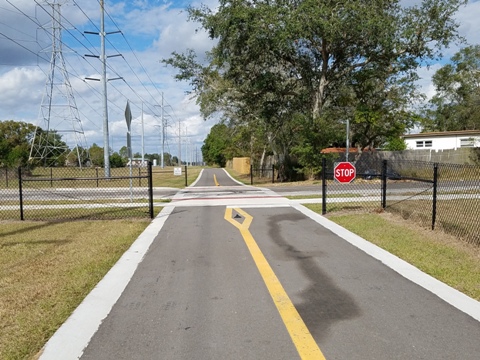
[225,208,325,360]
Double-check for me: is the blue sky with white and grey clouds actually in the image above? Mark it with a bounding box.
[0,0,480,160]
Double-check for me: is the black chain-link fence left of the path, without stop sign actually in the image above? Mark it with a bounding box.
[0,164,153,220]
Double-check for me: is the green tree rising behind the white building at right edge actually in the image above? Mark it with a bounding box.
[422,45,480,131]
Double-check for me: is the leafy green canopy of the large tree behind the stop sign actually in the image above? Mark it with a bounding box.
[164,0,466,177]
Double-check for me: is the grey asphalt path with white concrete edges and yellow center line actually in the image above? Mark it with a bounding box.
[41,169,480,360]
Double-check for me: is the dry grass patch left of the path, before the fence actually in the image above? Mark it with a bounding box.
[0,220,150,359]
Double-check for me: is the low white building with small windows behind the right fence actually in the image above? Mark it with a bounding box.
[403,130,480,151]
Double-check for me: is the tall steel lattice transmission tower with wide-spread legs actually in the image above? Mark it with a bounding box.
[30,0,88,167]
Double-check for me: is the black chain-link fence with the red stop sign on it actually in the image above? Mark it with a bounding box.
[322,153,480,245]
